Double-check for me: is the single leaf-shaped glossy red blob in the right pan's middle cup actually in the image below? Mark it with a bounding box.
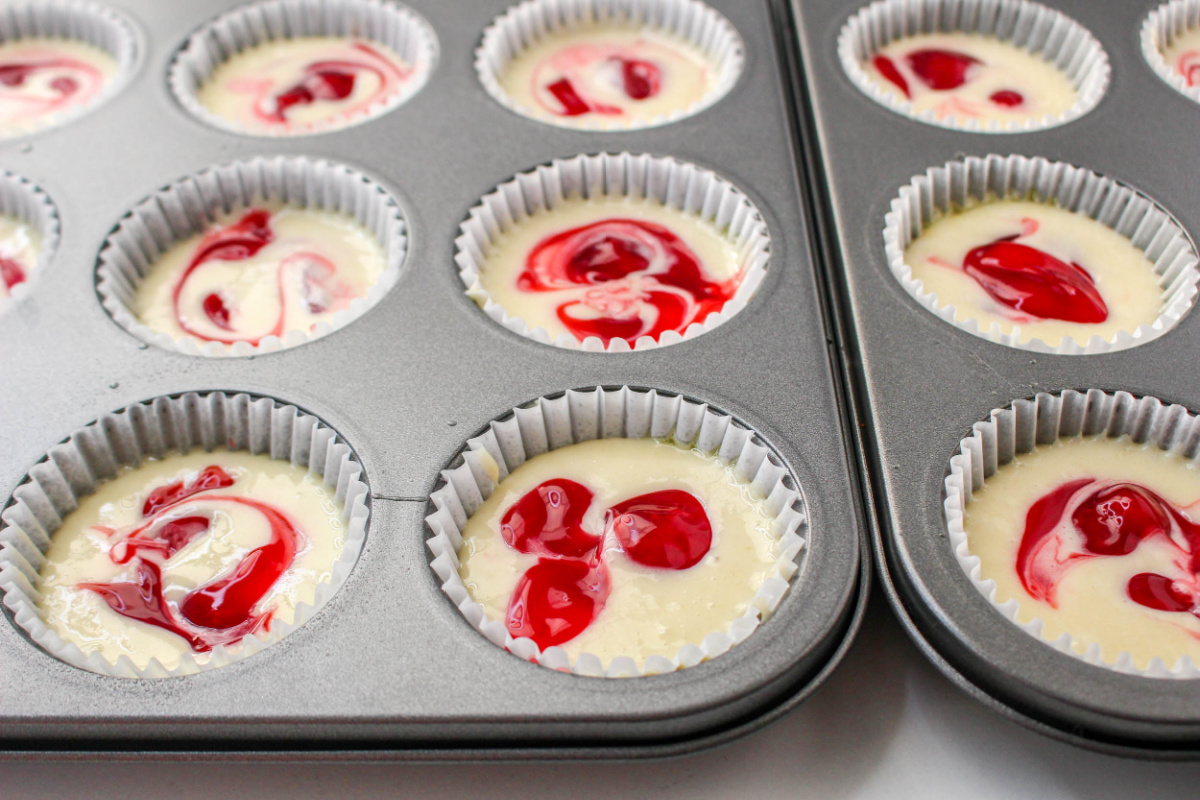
[962,235,1109,323]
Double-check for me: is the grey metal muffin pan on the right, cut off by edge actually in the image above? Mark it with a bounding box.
[791,0,1200,758]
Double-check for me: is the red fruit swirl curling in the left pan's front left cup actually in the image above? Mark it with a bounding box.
[78,465,300,652]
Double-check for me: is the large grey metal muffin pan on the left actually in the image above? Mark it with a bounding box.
[0,0,870,758]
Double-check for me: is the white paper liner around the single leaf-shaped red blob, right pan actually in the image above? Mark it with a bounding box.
[883,155,1200,355]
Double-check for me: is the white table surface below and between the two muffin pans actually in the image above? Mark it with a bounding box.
[0,597,1200,800]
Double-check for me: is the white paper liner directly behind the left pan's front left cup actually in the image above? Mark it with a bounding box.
[96,156,408,356]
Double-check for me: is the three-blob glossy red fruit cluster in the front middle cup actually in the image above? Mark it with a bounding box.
[500,479,713,650]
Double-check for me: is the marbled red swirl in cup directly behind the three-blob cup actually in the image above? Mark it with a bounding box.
[517,218,739,344]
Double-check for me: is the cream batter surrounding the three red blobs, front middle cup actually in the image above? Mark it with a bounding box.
[458,439,779,664]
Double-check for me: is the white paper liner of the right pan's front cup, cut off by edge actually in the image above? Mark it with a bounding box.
[944,389,1200,679]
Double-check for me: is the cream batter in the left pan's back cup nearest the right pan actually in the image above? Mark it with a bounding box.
[499,23,716,128]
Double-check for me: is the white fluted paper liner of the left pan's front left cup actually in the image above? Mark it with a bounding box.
[0,392,370,678]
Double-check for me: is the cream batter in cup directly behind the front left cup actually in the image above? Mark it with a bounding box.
[132,204,385,345]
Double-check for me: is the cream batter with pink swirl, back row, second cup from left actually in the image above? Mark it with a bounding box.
[197,36,413,134]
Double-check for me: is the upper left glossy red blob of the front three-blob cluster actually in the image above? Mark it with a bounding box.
[500,479,600,558]
